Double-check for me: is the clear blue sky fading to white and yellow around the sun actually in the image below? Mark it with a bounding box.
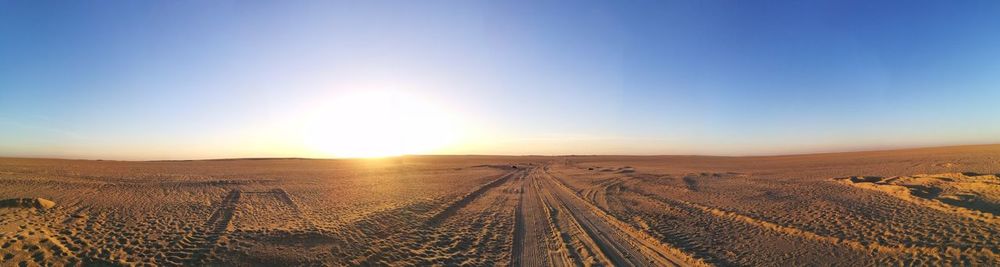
[0,0,1000,159]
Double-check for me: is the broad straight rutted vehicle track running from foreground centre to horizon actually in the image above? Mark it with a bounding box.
[511,167,704,266]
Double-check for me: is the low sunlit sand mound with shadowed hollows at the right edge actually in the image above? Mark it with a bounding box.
[835,172,1000,221]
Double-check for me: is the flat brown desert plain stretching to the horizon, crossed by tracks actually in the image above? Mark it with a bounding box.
[0,145,1000,266]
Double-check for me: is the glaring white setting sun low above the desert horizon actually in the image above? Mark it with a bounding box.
[304,92,458,158]
